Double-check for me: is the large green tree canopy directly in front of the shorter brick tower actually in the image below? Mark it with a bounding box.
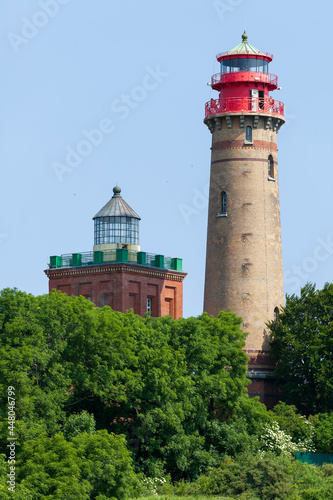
[0,290,247,479]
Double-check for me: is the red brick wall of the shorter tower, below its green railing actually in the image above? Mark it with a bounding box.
[45,264,186,319]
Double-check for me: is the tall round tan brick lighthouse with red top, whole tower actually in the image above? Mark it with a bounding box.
[204,32,284,406]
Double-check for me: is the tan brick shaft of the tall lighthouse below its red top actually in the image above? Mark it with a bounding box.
[204,115,284,360]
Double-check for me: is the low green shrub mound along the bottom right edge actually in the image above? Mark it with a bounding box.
[169,454,333,500]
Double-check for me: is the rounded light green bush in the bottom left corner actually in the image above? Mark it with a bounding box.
[0,430,140,500]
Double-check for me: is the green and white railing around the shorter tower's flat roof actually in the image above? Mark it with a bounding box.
[49,248,183,271]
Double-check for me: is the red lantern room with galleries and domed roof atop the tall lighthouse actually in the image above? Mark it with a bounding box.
[205,31,284,118]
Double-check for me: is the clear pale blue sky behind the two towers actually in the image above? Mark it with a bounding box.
[0,0,333,316]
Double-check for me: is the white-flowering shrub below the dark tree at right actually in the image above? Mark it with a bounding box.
[261,422,315,455]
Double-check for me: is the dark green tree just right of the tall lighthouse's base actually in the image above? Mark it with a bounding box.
[270,284,333,415]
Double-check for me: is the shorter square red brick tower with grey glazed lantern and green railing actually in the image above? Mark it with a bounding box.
[45,186,186,319]
